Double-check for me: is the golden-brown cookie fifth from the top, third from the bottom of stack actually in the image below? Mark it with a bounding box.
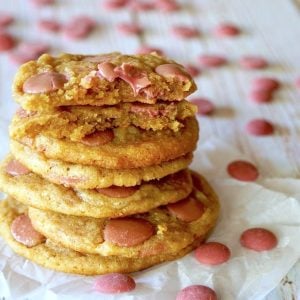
[0,156,192,218]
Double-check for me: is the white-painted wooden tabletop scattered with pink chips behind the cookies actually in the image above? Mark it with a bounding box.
[0,0,300,300]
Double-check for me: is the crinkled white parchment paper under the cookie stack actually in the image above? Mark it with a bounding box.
[0,139,300,300]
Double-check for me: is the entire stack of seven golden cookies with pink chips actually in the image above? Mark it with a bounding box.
[0,53,219,274]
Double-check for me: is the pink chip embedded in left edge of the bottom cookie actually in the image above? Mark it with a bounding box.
[10,214,45,248]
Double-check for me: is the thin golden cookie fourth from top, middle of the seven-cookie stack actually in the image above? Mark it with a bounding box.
[11,140,192,189]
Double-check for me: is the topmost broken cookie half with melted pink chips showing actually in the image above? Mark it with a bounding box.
[13,52,196,111]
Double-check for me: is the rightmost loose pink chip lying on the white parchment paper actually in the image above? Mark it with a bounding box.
[240,228,278,252]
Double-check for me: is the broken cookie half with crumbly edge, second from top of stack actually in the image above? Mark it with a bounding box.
[10,100,197,142]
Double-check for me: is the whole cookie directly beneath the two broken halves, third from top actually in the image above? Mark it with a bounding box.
[15,117,199,169]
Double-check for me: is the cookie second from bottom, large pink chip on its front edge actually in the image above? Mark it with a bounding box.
[29,172,218,257]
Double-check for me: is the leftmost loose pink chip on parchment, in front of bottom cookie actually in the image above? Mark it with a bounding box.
[94,273,136,294]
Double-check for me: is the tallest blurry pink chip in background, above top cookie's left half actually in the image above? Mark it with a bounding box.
[63,16,96,40]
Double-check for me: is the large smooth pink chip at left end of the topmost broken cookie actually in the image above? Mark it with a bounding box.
[23,72,67,94]
